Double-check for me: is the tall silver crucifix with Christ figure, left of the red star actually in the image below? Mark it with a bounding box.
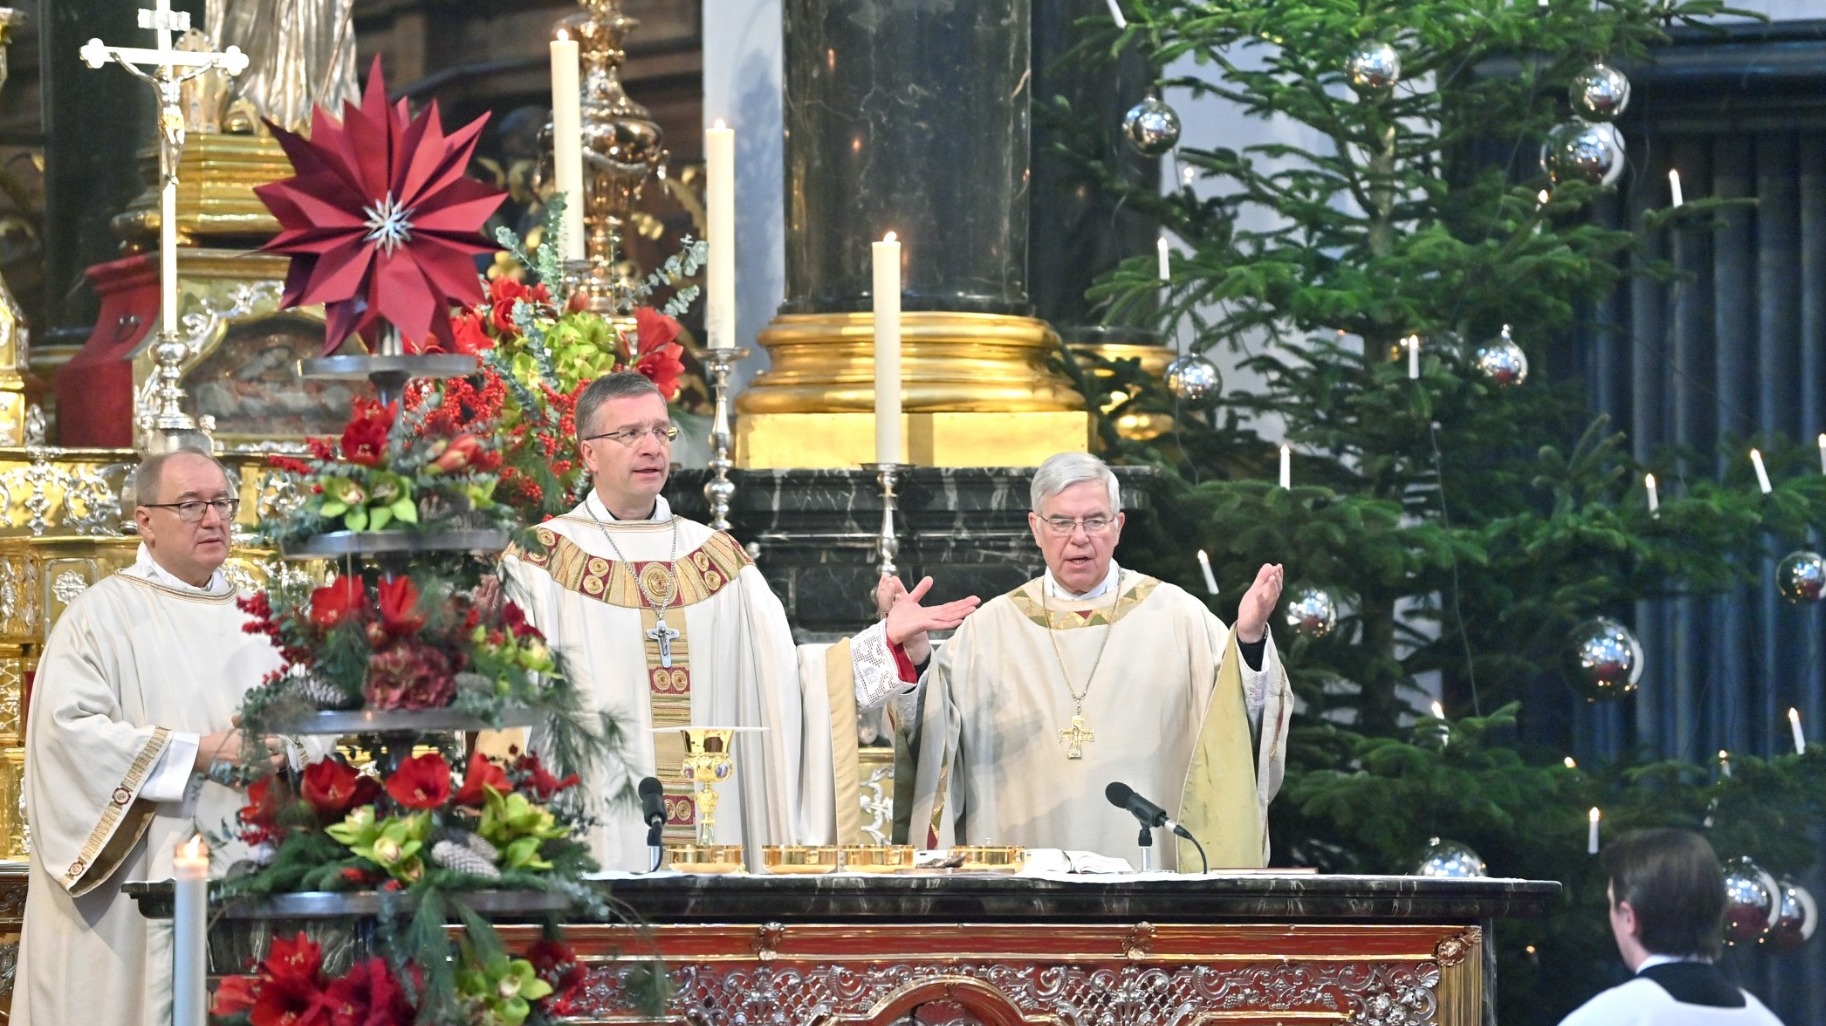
[80,0,247,451]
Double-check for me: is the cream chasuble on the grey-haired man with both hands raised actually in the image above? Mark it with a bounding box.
[911,571,1293,871]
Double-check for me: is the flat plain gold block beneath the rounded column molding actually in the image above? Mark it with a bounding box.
[736,411,1092,469]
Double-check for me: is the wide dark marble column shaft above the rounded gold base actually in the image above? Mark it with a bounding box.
[780,0,1029,316]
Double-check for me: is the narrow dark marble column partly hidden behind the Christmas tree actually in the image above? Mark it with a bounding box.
[1028,0,1161,343]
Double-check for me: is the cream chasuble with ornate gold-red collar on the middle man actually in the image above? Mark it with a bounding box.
[502,495,834,871]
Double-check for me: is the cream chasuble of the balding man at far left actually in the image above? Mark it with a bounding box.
[13,573,279,1026]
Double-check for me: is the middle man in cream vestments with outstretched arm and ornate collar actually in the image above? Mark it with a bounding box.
[502,372,975,871]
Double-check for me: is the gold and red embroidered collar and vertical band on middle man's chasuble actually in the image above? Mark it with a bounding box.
[509,517,754,843]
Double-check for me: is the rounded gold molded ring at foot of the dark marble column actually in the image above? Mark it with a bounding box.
[736,310,1085,412]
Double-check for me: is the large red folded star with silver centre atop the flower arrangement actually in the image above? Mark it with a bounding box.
[254,57,506,352]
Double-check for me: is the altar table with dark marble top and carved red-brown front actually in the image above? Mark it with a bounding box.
[509,874,1559,1026]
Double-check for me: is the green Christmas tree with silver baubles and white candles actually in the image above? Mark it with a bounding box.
[1052,0,1826,1022]
